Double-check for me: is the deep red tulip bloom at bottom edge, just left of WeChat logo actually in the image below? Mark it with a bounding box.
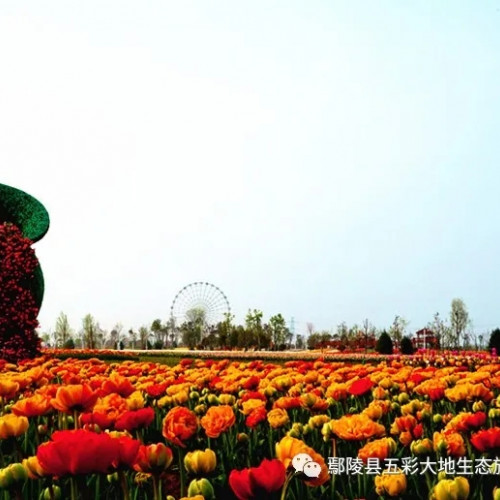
[229,459,286,500]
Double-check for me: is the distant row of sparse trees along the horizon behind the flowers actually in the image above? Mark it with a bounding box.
[41,299,500,352]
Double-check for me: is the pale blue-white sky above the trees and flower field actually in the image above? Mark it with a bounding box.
[0,0,500,333]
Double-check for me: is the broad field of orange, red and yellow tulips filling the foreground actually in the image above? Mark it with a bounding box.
[0,353,500,500]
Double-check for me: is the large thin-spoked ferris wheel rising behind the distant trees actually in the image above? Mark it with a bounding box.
[170,281,231,326]
